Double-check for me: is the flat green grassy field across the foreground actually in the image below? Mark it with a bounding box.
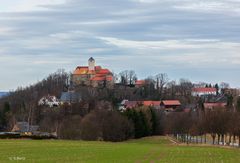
[0,137,240,163]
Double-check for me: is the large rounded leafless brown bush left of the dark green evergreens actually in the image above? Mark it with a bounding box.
[81,110,134,142]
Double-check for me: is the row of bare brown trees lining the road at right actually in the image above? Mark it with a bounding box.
[165,108,240,147]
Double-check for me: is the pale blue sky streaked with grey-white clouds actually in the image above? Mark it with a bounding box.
[0,0,240,91]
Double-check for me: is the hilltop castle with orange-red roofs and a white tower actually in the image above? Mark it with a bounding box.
[72,57,114,88]
